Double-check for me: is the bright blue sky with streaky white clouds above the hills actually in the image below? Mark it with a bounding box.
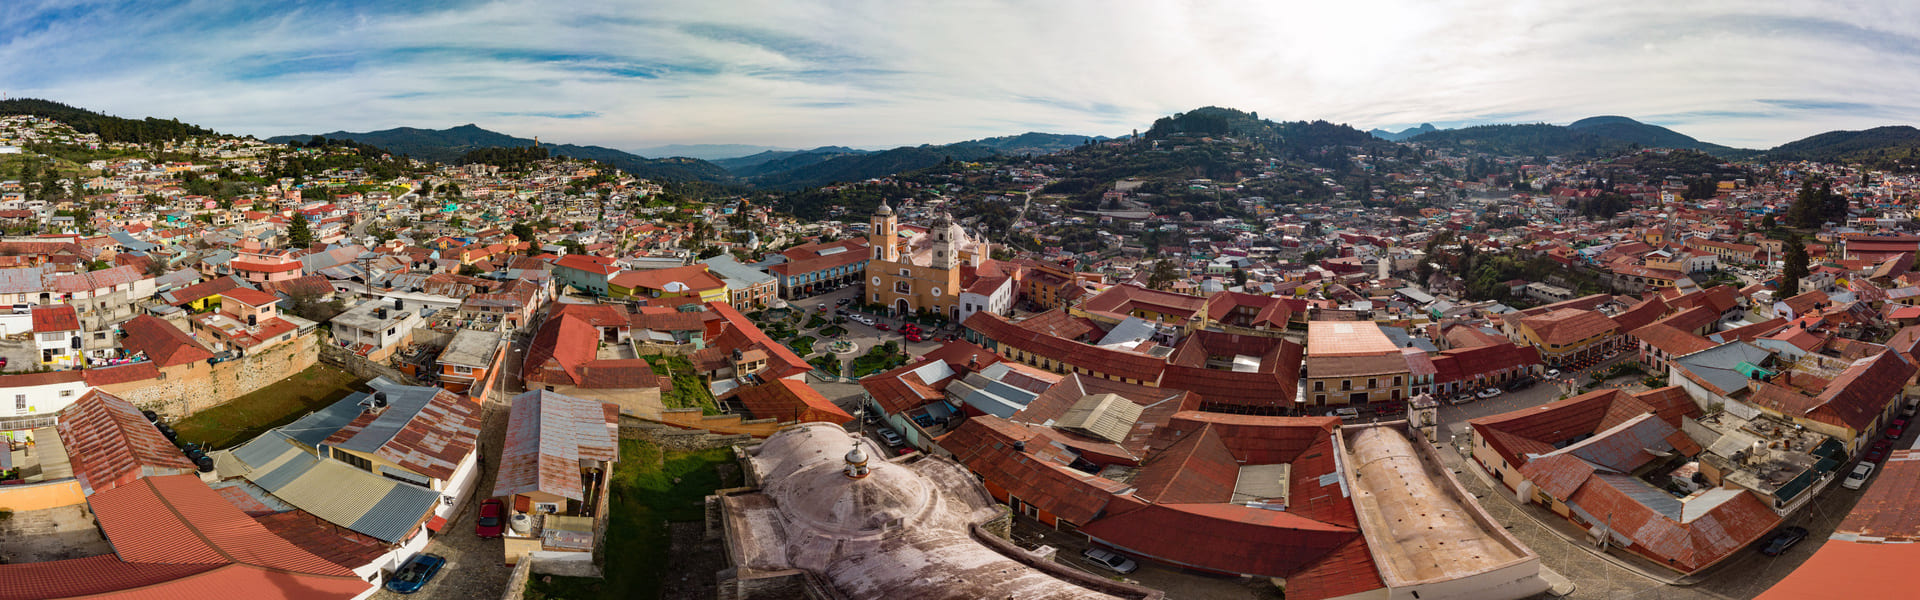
[0,0,1920,148]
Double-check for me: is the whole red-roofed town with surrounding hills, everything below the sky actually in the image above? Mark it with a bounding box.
[11,100,1920,600]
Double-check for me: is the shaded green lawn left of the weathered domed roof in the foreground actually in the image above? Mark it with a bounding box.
[526,440,741,600]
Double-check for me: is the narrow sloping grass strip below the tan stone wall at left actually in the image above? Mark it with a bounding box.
[173,363,369,448]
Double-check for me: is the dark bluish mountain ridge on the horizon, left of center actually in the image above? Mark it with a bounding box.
[267,123,732,183]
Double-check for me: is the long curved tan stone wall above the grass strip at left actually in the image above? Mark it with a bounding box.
[100,335,319,419]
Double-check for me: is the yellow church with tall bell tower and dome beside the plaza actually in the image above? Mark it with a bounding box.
[866,202,993,319]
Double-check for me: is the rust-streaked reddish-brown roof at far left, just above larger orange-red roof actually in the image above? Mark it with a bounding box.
[58,390,194,494]
